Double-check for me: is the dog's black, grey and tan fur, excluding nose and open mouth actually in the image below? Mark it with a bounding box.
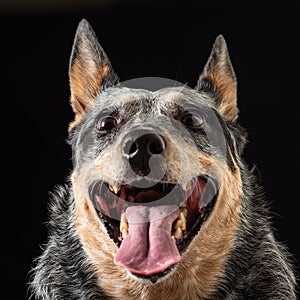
[31,20,296,300]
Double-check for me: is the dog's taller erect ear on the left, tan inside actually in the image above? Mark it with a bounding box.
[69,19,118,131]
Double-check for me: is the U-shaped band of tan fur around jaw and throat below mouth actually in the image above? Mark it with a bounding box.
[72,163,241,300]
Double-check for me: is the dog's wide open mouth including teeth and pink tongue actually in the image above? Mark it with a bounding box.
[89,175,217,282]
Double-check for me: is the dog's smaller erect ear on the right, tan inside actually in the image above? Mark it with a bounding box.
[196,35,238,121]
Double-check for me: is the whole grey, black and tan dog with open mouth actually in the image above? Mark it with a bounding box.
[31,20,296,300]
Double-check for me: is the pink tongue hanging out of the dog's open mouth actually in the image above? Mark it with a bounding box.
[115,205,180,275]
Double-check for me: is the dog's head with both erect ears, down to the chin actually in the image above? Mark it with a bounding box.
[69,21,244,285]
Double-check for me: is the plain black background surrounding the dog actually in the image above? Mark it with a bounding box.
[0,1,300,299]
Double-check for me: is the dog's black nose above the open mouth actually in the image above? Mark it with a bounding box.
[122,130,166,176]
